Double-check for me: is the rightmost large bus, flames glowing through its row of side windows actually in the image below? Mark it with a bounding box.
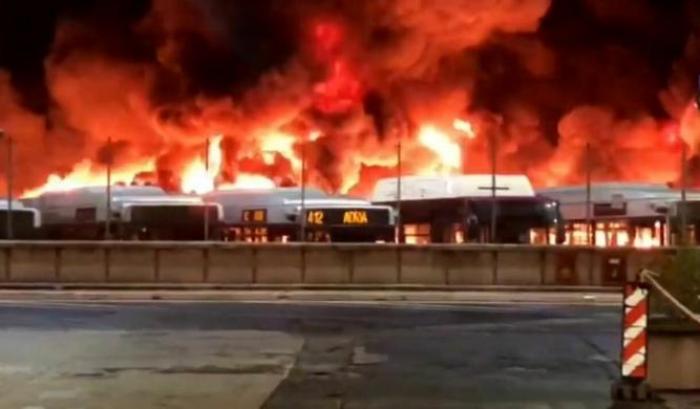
[539,182,700,247]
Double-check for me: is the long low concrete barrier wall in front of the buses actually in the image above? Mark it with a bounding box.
[0,242,672,286]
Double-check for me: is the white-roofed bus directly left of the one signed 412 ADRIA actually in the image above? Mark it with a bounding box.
[23,186,222,240]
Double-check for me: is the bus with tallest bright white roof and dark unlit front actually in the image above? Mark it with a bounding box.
[372,175,564,244]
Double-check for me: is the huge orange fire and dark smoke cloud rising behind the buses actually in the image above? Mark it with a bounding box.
[0,0,700,196]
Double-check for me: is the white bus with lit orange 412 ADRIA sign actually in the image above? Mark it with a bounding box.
[204,187,395,242]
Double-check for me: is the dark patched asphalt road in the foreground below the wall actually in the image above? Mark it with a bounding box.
[0,301,620,409]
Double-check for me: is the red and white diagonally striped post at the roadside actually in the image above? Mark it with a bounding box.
[621,282,649,382]
